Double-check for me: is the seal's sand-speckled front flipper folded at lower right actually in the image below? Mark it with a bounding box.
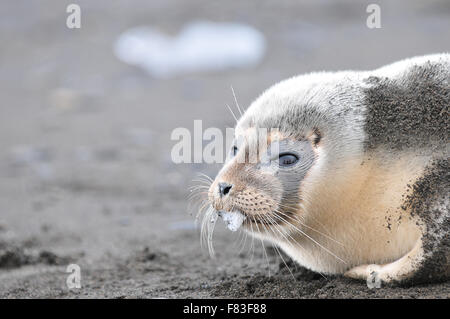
[344,158,450,286]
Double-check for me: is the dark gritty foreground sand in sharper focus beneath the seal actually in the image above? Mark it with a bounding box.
[0,235,450,298]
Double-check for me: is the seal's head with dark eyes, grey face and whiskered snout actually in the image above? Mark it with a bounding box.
[208,74,368,250]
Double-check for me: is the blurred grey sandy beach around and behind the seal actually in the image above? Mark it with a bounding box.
[0,0,450,297]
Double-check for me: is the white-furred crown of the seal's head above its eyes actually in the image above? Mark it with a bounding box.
[236,72,361,141]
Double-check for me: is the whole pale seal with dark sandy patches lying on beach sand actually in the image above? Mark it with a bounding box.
[202,54,450,283]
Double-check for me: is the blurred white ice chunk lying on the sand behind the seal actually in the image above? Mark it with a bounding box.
[114,21,266,78]
